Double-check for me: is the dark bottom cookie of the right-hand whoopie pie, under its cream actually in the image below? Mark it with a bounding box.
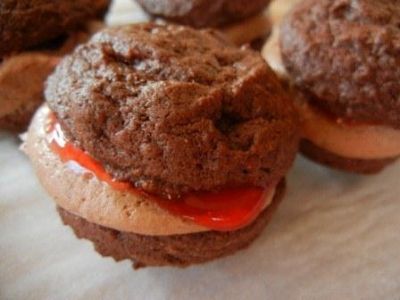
[300,140,398,174]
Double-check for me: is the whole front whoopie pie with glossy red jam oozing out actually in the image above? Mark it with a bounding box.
[24,24,298,267]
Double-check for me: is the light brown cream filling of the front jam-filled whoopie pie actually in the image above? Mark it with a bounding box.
[22,106,275,235]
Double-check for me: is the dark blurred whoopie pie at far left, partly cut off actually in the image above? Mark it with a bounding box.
[0,0,109,131]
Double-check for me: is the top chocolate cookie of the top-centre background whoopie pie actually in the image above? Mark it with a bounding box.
[136,0,270,28]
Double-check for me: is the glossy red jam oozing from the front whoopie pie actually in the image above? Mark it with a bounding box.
[47,115,267,231]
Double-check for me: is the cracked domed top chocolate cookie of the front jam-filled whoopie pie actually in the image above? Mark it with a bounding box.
[46,24,298,197]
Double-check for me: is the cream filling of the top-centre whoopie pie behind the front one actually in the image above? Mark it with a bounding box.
[220,13,271,45]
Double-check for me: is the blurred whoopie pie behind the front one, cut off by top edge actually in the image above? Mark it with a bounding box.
[136,0,270,46]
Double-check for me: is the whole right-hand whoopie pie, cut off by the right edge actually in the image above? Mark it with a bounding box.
[263,0,400,174]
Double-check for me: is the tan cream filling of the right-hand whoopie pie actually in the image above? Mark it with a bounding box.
[262,27,400,160]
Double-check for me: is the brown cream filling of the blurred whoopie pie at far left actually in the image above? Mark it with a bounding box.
[0,21,103,118]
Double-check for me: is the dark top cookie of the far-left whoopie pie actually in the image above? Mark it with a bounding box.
[0,0,110,57]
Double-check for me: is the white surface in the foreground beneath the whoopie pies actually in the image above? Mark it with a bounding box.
[0,0,400,300]
